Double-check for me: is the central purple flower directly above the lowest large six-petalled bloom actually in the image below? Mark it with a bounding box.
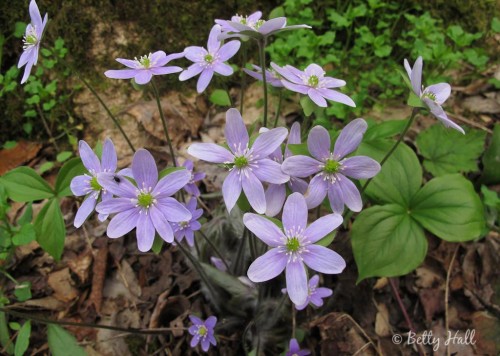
[188,109,290,214]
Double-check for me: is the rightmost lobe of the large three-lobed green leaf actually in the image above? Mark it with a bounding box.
[410,174,485,242]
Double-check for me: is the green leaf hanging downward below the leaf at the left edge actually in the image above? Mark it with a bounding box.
[35,198,66,261]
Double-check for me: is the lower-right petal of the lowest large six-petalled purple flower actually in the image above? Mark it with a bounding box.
[302,245,345,274]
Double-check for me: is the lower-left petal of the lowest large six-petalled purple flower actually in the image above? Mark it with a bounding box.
[247,248,288,282]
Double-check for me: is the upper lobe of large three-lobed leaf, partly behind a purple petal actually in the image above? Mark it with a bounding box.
[356,140,422,207]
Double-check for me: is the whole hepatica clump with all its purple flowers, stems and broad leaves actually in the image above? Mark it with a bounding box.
[1,0,484,355]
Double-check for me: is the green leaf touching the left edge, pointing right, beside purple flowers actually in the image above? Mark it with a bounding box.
[0,167,54,202]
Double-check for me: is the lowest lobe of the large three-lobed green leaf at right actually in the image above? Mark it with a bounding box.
[351,204,427,282]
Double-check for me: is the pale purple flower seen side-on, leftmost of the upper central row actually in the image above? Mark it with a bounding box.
[104,51,184,85]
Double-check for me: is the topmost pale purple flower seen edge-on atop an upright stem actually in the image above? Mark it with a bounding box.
[215,11,311,39]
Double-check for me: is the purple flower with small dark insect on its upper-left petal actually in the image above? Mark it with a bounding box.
[96,149,191,252]
